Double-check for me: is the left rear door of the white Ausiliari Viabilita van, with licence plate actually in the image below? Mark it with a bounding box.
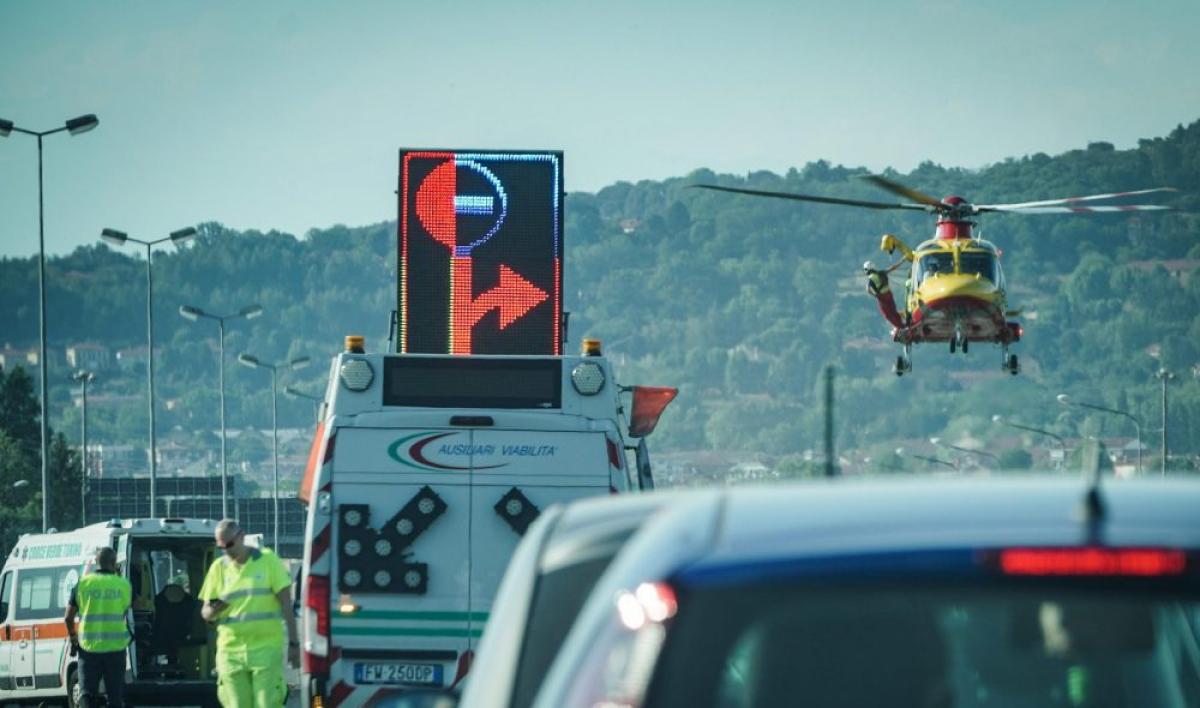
[330,426,472,704]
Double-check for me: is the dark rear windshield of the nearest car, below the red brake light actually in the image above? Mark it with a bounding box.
[644,586,1200,708]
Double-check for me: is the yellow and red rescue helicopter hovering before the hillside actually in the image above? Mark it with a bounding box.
[692,175,1175,376]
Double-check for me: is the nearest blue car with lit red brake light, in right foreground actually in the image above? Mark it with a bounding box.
[534,478,1200,708]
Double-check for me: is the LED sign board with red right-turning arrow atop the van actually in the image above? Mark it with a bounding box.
[396,150,563,354]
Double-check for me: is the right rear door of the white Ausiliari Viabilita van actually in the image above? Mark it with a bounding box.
[470,428,612,637]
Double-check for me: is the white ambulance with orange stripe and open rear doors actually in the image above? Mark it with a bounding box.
[0,518,223,707]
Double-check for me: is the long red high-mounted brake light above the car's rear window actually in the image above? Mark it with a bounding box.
[1000,548,1187,577]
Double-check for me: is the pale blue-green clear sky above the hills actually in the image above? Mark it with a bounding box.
[0,0,1200,256]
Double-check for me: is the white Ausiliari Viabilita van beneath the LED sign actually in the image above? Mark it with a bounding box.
[300,337,676,707]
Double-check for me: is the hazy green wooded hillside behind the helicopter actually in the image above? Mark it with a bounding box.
[0,122,1200,477]
